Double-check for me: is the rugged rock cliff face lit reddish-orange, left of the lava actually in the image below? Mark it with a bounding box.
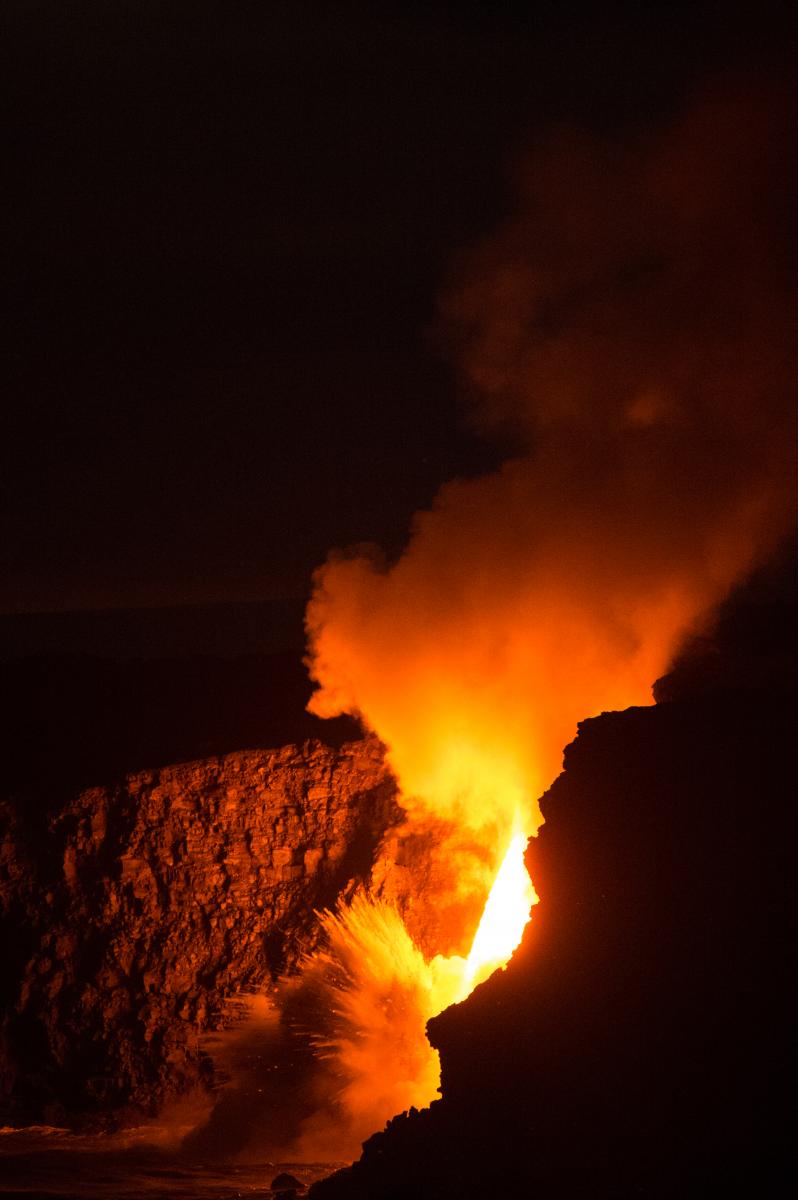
[0,740,400,1122]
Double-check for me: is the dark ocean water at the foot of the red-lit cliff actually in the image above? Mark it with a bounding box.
[0,1126,343,1200]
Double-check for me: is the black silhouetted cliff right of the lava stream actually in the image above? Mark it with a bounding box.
[313,691,798,1200]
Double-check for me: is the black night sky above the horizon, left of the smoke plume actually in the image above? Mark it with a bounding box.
[0,0,791,612]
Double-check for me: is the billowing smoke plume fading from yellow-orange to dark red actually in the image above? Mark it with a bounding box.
[307,77,798,926]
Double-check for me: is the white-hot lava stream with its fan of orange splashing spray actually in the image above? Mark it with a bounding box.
[287,832,538,1160]
